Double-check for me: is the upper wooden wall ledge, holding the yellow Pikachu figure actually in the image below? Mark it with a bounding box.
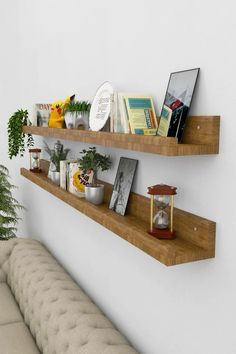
[23,116,220,156]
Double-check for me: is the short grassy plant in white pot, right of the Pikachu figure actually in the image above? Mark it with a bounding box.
[64,100,91,129]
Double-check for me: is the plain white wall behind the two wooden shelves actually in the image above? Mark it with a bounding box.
[0,0,236,354]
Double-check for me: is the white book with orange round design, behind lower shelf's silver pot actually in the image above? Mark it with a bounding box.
[68,162,93,197]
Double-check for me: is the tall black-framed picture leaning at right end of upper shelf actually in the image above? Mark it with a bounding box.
[157,68,200,141]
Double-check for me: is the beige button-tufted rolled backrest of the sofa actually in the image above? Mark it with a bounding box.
[7,239,137,354]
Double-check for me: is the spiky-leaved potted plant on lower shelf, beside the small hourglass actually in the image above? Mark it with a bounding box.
[44,140,70,185]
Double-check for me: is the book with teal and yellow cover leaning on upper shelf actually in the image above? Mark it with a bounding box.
[124,94,157,134]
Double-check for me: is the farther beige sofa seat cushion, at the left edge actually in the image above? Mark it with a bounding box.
[0,283,23,324]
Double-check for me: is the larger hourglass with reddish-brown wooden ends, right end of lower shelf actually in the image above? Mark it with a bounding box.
[148,184,177,240]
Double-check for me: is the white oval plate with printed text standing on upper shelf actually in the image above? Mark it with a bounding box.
[89,81,114,131]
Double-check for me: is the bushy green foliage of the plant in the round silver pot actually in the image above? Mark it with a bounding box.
[79,147,111,185]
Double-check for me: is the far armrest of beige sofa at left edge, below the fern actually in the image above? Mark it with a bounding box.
[0,238,18,282]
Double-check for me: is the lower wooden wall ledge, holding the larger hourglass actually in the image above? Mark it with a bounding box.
[21,168,216,266]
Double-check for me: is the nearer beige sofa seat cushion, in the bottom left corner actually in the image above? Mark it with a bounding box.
[0,322,40,354]
